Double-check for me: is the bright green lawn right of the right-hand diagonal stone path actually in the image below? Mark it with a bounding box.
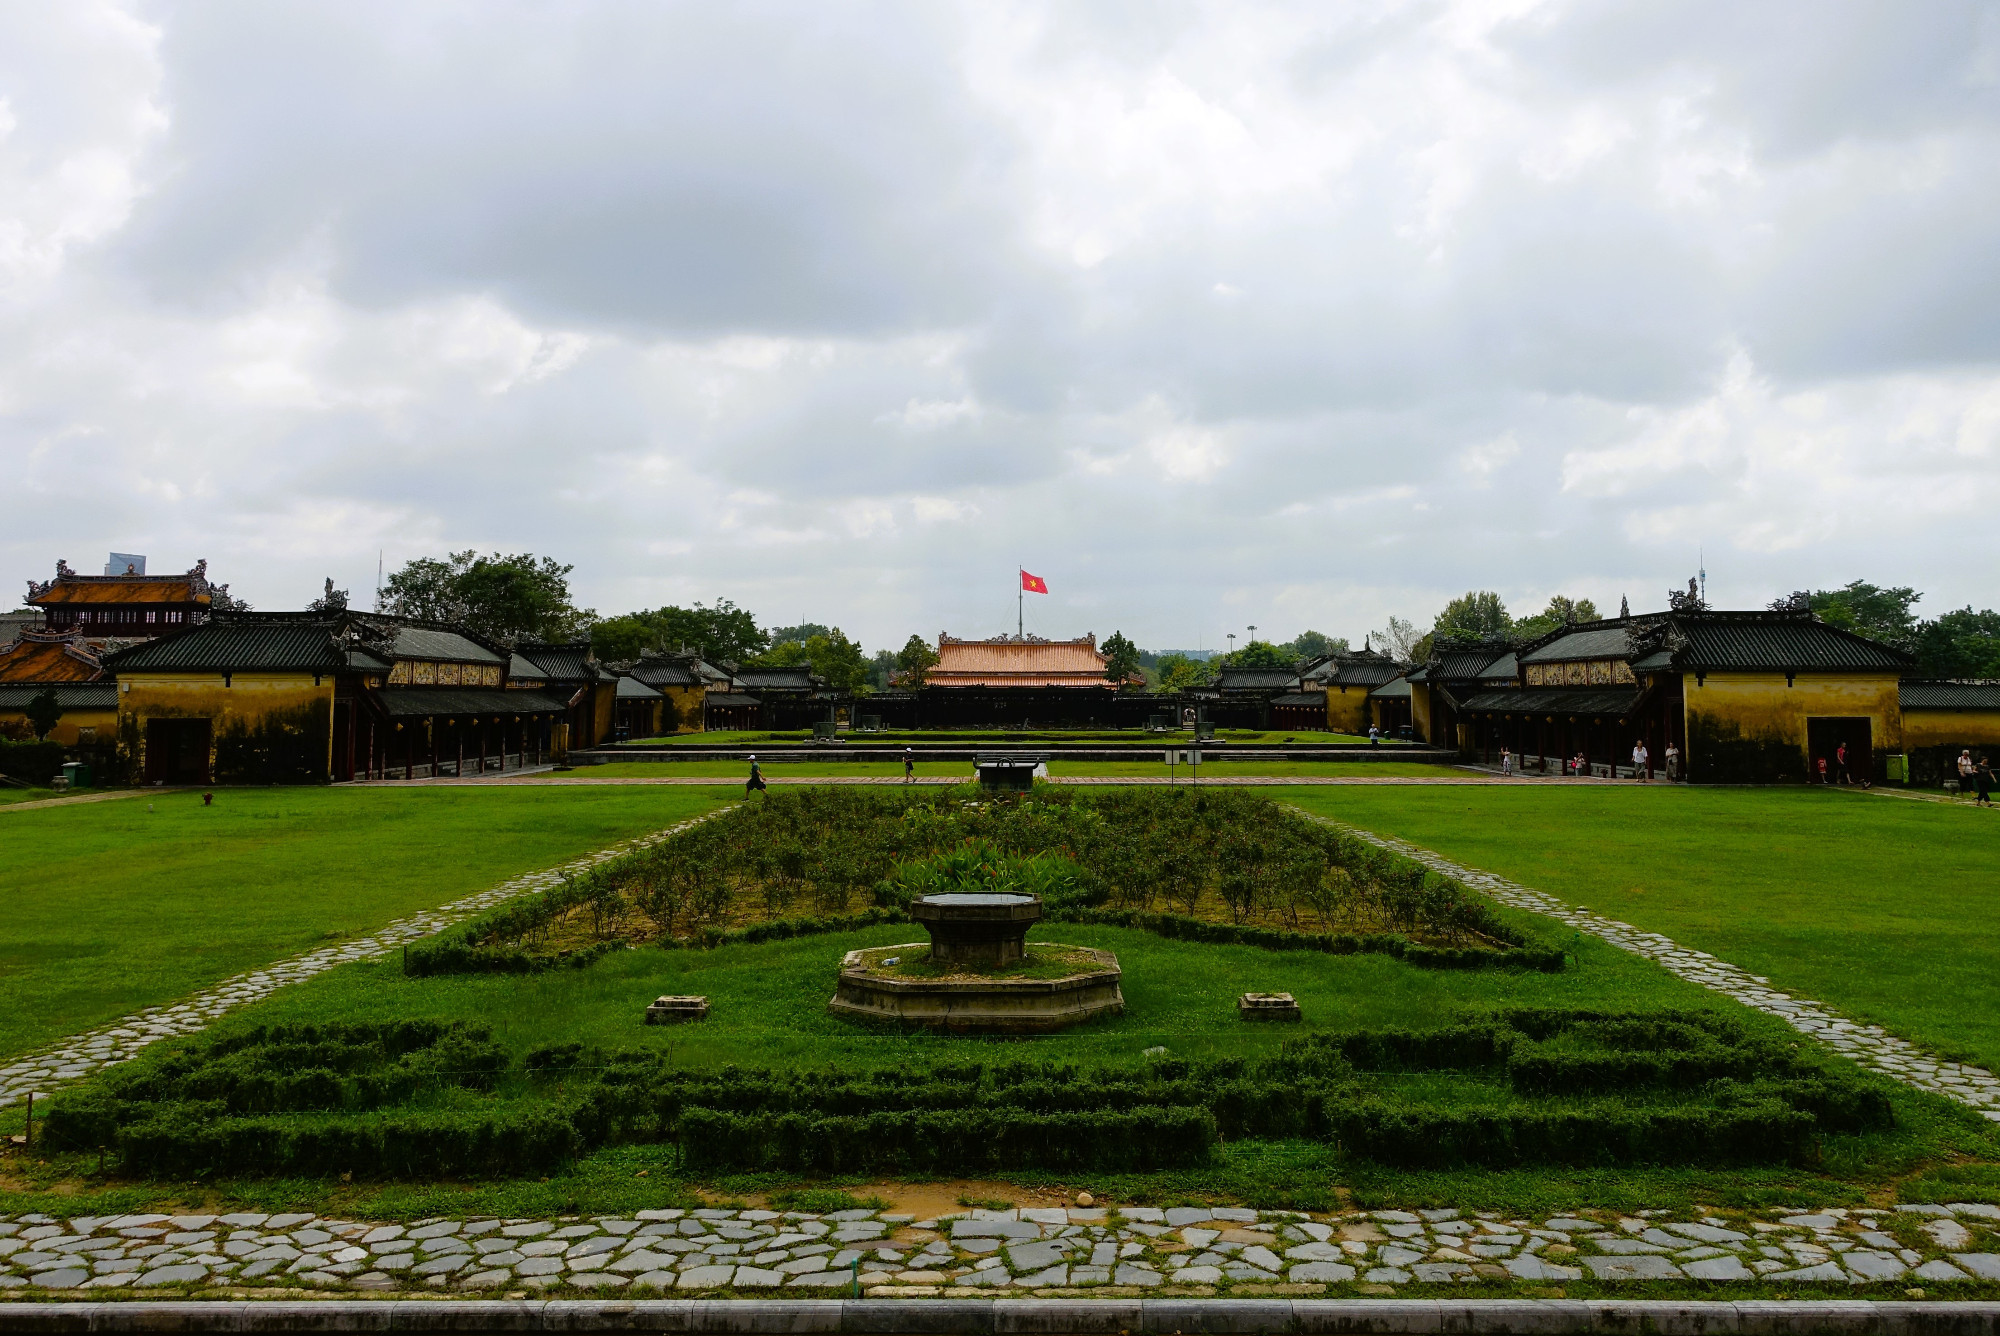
[1274,784,2000,1068]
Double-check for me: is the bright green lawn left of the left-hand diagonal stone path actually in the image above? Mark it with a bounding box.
[0,788,730,1056]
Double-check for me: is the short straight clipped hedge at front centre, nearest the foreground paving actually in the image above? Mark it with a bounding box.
[680,1104,1216,1174]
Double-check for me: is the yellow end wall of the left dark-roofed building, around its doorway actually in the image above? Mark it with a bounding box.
[118,672,334,784]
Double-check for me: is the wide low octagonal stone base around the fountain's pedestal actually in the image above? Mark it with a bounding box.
[826,942,1124,1034]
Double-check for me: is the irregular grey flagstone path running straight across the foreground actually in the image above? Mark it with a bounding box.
[0,1202,2000,1296]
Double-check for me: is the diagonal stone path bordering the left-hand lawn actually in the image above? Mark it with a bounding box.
[0,814,712,1108]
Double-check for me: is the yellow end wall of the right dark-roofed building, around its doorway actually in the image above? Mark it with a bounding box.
[1682,672,1904,782]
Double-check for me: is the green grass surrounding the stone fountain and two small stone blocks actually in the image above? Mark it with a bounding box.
[168,910,1754,1066]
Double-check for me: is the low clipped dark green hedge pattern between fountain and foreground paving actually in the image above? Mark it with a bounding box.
[46,1008,1894,1178]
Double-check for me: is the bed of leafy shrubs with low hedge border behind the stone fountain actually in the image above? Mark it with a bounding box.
[408,788,1562,974]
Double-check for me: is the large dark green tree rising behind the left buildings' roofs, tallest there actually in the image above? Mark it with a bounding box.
[382,550,598,640]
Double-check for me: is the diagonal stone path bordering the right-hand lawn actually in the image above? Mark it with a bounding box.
[1312,816,2000,1122]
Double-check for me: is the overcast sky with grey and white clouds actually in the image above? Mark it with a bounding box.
[0,0,2000,648]
